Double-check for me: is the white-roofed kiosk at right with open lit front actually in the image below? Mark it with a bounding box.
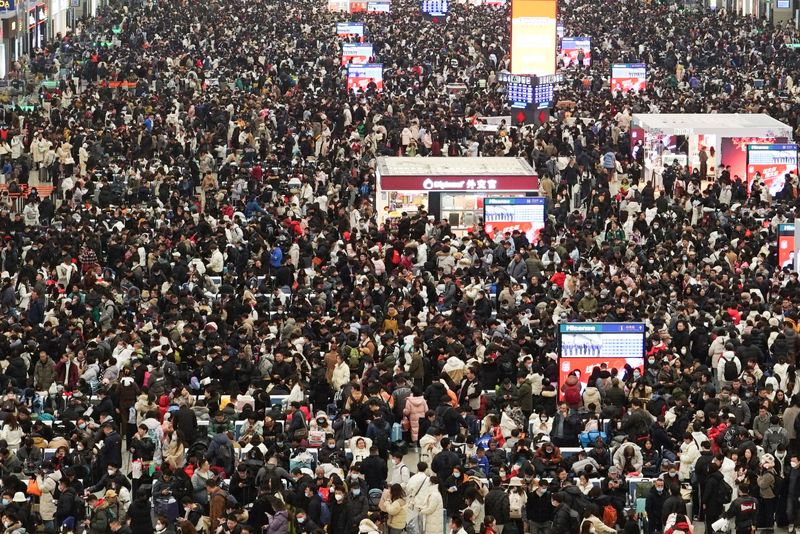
[631,113,792,193]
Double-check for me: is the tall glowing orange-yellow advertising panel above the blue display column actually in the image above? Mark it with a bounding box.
[511,0,556,76]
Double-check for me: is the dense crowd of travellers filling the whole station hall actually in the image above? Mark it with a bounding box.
[0,0,800,534]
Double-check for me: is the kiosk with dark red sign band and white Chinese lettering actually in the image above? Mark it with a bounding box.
[376,157,539,233]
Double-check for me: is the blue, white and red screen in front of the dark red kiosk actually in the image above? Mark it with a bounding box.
[483,197,547,244]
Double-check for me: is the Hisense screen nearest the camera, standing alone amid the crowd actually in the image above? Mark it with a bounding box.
[558,323,647,399]
